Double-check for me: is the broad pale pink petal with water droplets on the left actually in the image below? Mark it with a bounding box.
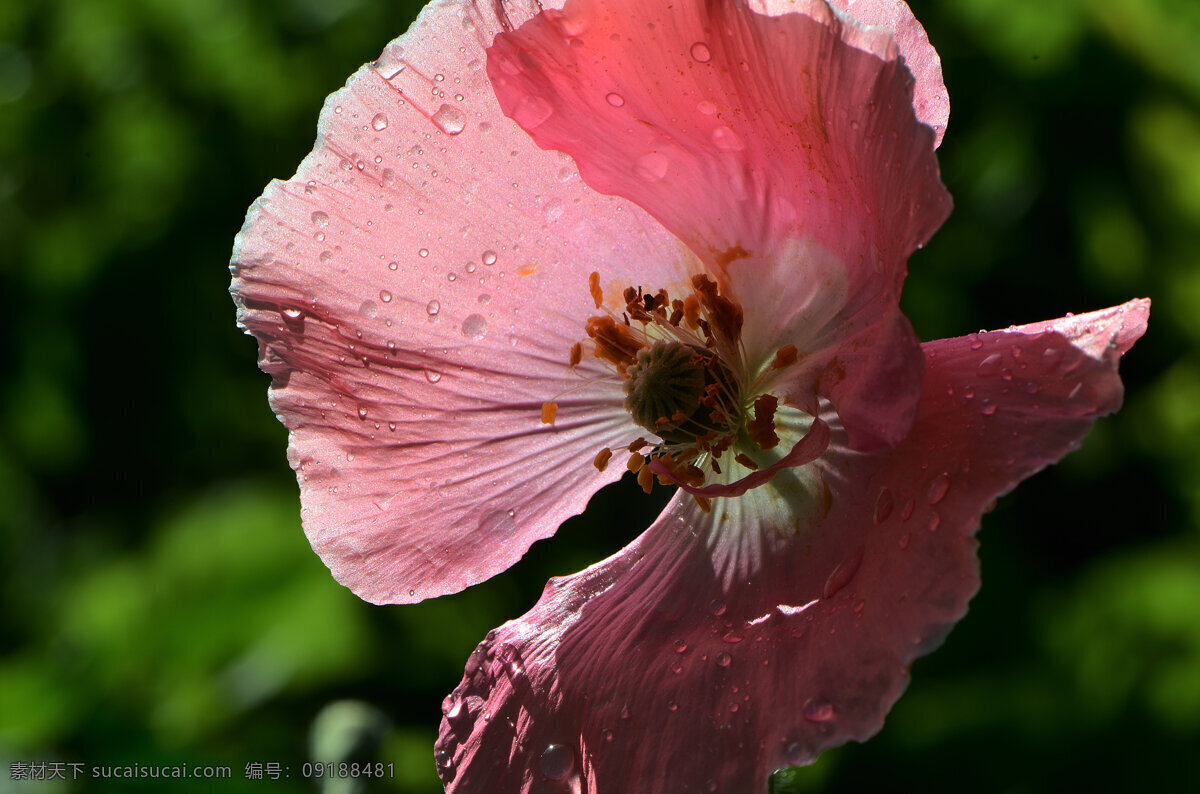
[233,2,698,602]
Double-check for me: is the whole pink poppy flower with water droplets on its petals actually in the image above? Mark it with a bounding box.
[233,0,1148,793]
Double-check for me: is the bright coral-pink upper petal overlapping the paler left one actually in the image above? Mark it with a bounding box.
[487,0,950,449]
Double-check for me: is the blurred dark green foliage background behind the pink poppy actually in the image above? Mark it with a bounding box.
[0,0,1200,794]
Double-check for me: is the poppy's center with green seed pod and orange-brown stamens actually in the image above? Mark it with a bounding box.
[542,273,816,510]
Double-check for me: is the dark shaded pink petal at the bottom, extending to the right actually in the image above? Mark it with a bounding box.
[438,301,1148,794]
